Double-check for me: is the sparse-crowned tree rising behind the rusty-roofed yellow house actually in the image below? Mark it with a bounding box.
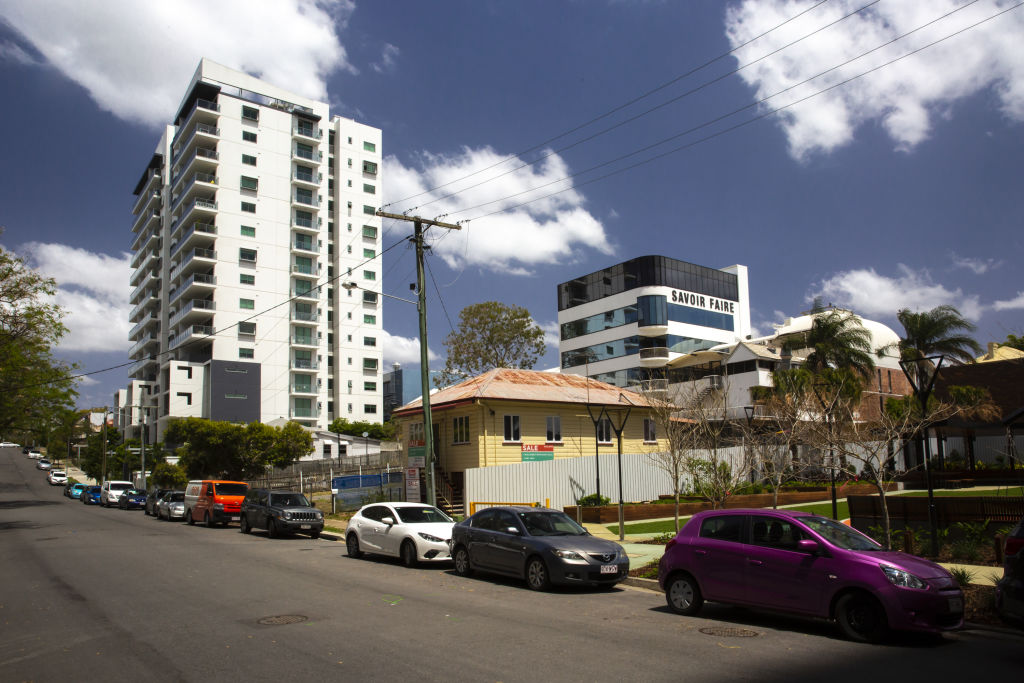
[434,301,546,387]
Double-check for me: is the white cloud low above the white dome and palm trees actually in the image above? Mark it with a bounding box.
[808,263,984,319]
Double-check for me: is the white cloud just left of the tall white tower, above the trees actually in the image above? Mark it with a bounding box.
[17,242,131,351]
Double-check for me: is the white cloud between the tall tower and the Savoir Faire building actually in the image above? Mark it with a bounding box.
[384,147,612,275]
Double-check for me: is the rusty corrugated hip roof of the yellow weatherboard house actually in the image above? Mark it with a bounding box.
[394,368,648,414]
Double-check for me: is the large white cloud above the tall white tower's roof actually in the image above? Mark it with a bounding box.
[0,0,355,126]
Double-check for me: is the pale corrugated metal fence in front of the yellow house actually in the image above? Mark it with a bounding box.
[465,447,740,512]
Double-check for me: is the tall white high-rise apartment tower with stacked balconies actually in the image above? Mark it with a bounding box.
[115,59,383,440]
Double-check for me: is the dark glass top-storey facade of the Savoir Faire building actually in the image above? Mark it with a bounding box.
[558,256,739,310]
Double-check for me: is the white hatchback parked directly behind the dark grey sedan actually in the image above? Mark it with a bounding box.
[345,503,455,566]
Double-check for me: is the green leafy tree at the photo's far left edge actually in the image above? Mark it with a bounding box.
[0,240,77,438]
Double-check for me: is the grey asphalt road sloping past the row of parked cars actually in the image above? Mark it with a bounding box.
[0,449,1024,683]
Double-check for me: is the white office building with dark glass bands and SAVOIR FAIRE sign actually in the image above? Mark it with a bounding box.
[558,256,751,387]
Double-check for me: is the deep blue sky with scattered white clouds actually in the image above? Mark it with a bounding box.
[0,0,1024,408]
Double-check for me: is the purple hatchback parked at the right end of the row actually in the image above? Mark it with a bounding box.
[657,510,964,642]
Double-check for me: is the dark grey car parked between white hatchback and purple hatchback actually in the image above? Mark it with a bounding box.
[452,507,630,591]
